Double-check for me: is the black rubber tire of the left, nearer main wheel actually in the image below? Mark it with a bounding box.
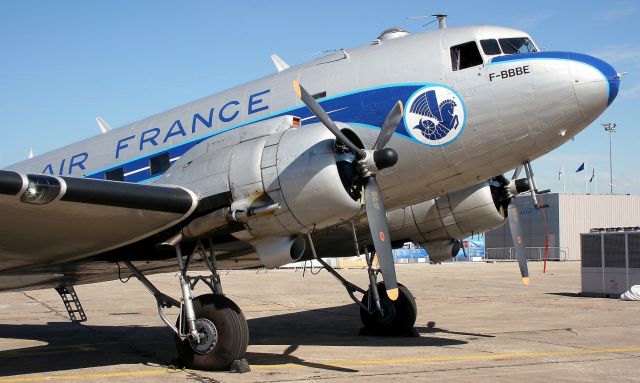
[175,294,249,371]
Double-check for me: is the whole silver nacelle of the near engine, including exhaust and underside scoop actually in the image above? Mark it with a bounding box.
[161,116,362,267]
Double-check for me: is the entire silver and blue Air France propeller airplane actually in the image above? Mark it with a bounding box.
[0,19,619,369]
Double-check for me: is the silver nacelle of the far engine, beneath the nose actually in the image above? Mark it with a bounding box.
[388,182,505,246]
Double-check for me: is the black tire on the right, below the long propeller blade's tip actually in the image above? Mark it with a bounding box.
[360,282,418,335]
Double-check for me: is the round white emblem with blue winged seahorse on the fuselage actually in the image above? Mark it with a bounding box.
[404,85,465,146]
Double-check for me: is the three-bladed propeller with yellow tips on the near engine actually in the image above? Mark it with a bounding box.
[293,80,403,301]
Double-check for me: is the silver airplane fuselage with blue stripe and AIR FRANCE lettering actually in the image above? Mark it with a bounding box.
[2,26,617,237]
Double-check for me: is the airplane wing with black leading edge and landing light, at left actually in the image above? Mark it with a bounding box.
[0,171,198,271]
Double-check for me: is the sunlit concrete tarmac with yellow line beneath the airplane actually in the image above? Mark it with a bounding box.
[0,262,640,383]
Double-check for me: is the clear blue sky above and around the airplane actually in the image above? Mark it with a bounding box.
[0,0,640,194]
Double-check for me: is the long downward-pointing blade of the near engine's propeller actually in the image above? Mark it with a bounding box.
[364,177,398,301]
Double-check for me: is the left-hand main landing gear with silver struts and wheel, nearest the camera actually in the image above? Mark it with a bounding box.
[125,236,249,372]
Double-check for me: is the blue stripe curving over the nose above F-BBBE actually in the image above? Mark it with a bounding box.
[487,52,620,106]
